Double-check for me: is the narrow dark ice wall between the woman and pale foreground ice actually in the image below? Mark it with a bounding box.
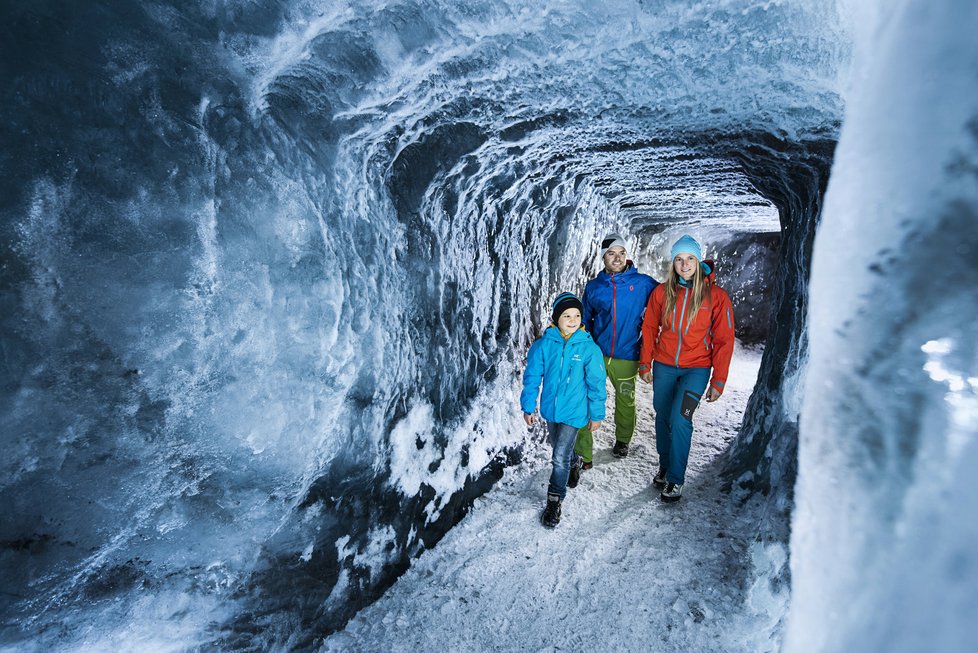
[724,141,834,510]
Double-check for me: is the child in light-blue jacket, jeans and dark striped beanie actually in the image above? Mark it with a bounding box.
[520,292,607,528]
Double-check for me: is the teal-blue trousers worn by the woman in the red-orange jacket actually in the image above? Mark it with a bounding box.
[652,362,710,483]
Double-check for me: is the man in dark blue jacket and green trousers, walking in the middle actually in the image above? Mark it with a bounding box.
[568,234,659,487]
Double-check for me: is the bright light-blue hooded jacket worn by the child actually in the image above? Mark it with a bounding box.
[520,327,608,428]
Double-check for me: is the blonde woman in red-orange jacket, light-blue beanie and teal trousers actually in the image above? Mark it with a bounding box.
[638,235,734,502]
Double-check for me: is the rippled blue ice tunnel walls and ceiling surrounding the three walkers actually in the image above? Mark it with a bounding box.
[0,0,975,650]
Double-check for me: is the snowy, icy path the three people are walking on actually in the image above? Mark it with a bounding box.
[322,347,784,653]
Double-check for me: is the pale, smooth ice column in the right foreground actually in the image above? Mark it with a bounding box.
[785,0,978,653]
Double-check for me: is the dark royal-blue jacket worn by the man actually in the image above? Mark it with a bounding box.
[581,261,659,361]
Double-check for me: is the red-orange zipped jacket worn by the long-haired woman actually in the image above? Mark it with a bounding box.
[638,261,734,393]
